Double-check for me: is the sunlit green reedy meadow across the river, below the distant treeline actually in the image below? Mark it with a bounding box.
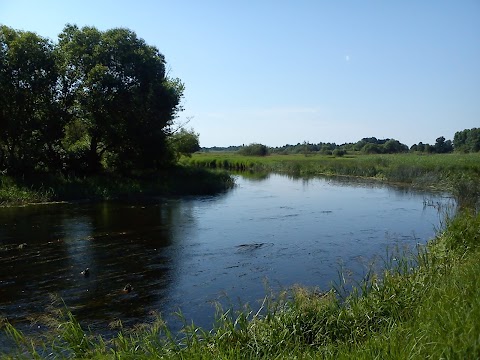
[183,153,480,187]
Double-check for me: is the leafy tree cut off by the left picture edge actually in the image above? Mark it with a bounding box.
[0,26,63,172]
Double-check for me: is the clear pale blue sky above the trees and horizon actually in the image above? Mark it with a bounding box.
[0,0,480,147]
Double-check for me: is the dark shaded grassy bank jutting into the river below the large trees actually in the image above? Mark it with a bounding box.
[0,166,233,205]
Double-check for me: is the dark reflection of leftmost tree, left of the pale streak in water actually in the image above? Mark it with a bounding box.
[0,205,70,321]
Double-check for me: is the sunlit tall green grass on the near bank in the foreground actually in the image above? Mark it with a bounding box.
[3,211,480,359]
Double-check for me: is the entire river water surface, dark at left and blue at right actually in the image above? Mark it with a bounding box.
[0,174,448,346]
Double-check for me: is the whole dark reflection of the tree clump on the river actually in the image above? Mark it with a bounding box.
[0,201,189,332]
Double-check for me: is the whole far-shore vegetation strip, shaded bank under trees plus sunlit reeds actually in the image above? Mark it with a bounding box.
[0,152,480,207]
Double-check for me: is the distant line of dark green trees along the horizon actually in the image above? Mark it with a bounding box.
[202,128,480,156]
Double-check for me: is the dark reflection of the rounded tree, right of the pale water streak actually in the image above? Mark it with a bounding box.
[60,202,188,330]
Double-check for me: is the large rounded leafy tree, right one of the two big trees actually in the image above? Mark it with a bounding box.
[58,25,183,172]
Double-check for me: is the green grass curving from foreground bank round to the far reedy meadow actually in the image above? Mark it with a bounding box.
[0,154,480,359]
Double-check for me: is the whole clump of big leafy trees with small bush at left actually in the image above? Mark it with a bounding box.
[0,25,199,175]
